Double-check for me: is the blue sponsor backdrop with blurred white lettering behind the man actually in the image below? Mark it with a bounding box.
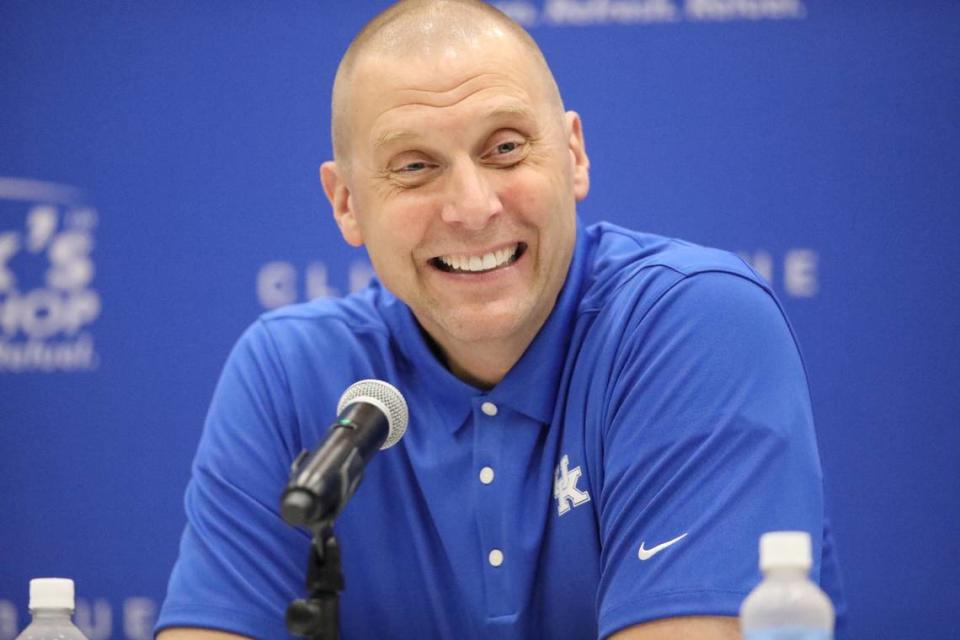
[0,0,960,640]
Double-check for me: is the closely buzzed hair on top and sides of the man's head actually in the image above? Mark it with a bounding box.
[331,0,563,169]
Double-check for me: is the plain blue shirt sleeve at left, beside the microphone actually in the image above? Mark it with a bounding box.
[156,320,309,638]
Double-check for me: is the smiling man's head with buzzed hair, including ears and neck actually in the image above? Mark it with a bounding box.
[321,3,589,387]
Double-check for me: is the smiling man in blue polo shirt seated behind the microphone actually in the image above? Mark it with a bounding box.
[158,1,837,640]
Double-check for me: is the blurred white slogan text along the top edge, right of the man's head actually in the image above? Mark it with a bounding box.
[493,0,807,27]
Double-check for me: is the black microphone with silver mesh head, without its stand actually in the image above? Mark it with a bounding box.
[280,380,408,526]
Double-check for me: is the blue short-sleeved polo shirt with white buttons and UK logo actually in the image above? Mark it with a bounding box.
[157,224,843,640]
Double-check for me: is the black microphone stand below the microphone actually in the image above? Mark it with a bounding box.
[286,518,344,640]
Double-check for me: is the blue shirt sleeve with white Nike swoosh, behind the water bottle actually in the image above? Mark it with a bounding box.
[598,272,823,637]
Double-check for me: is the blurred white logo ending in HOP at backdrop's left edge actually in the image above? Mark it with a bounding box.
[0,177,100,373]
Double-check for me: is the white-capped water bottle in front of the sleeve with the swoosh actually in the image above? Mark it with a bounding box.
[740,531,834,640]
